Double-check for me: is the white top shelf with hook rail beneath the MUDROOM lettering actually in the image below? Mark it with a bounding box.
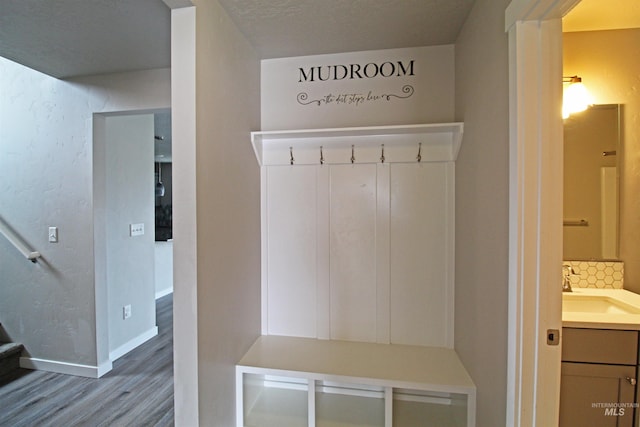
[251,123,463,166]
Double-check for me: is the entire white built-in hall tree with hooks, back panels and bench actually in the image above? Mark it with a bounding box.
[237,123,475,426]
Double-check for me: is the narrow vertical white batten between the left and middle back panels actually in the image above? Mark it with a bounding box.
[316,166,331,339]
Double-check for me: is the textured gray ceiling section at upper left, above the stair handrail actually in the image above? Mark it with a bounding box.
[0,0,171,77]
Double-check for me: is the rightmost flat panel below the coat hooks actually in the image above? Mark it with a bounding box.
[390,163,454,347]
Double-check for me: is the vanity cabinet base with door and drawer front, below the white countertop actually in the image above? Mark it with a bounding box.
[559,328,638,427]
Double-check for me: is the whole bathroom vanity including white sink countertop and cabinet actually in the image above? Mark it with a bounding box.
[559,288,640,427]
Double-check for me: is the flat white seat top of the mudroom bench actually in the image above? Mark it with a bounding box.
[238,335,475,394]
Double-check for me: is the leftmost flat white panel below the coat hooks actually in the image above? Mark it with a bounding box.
[266,166,317,337]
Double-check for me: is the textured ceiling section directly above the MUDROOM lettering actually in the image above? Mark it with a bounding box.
[219,0,474,58]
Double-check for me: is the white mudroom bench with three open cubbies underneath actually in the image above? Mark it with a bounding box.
[236,336,476,427]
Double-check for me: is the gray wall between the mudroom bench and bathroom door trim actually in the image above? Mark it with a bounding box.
[455,0,509,427]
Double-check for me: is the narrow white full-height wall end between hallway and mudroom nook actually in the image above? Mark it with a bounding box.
[171,7,200,426]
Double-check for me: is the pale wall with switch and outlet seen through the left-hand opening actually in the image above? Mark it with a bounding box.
[104,114,157,360]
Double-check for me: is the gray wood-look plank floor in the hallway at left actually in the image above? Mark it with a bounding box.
[0,295,174,427]
